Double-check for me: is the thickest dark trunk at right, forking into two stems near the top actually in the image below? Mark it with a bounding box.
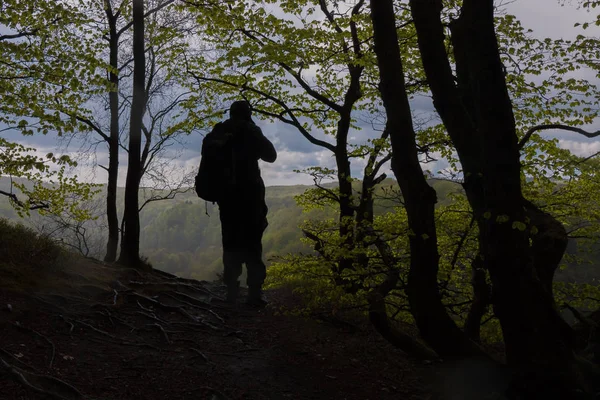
[410,0,592,398]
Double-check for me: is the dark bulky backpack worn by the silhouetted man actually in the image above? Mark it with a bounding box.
[195,124,236,202]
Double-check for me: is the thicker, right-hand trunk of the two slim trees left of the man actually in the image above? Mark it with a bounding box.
[119,0,146,267]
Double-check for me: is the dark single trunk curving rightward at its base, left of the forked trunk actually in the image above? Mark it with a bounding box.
[371,0,482,358]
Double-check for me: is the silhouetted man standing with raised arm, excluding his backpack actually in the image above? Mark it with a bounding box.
[215,101,277,306]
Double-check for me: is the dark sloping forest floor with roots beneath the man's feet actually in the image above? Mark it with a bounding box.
[0,259,431,400]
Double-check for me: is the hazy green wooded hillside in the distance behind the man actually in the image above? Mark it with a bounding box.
[0,178,460,279]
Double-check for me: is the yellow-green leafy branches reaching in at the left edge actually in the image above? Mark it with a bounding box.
[0,1,97,219]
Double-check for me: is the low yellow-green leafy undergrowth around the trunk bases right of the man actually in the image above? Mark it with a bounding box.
[266,194,600,343]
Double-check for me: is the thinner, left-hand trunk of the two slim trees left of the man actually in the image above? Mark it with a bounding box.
[104,0,119,262]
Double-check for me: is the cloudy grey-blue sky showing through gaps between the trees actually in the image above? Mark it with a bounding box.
[2,0,600,186]
